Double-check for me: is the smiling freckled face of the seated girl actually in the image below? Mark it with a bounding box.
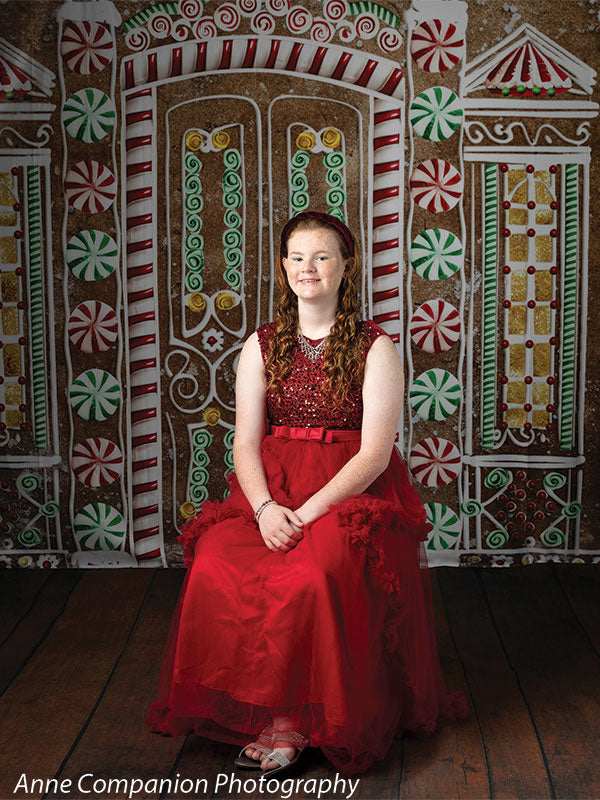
[282,228,348,301]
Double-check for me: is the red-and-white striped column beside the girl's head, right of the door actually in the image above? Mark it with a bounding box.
[372,98,404,342]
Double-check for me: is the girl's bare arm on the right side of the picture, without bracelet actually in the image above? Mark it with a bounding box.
[296,336,404,524]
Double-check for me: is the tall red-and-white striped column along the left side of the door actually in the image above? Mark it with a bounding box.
[124,88,166,566]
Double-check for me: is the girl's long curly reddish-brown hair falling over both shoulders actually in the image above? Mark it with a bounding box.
[265,211,368,406]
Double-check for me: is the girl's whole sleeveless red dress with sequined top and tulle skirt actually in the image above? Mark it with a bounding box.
[146,320,468,774]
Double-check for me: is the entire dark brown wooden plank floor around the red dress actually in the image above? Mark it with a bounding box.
[0,562,600,800]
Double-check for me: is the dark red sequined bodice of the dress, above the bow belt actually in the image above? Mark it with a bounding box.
[257,320,387,430]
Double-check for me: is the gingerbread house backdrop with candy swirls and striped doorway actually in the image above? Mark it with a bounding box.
[0,0,600,568]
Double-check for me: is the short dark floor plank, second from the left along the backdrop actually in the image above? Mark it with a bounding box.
[0,569,82,694]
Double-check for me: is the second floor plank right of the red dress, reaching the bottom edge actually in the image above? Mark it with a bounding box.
[439,568,552,800]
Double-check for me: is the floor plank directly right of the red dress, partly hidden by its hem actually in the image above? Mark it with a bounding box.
[399,567,490,800]
